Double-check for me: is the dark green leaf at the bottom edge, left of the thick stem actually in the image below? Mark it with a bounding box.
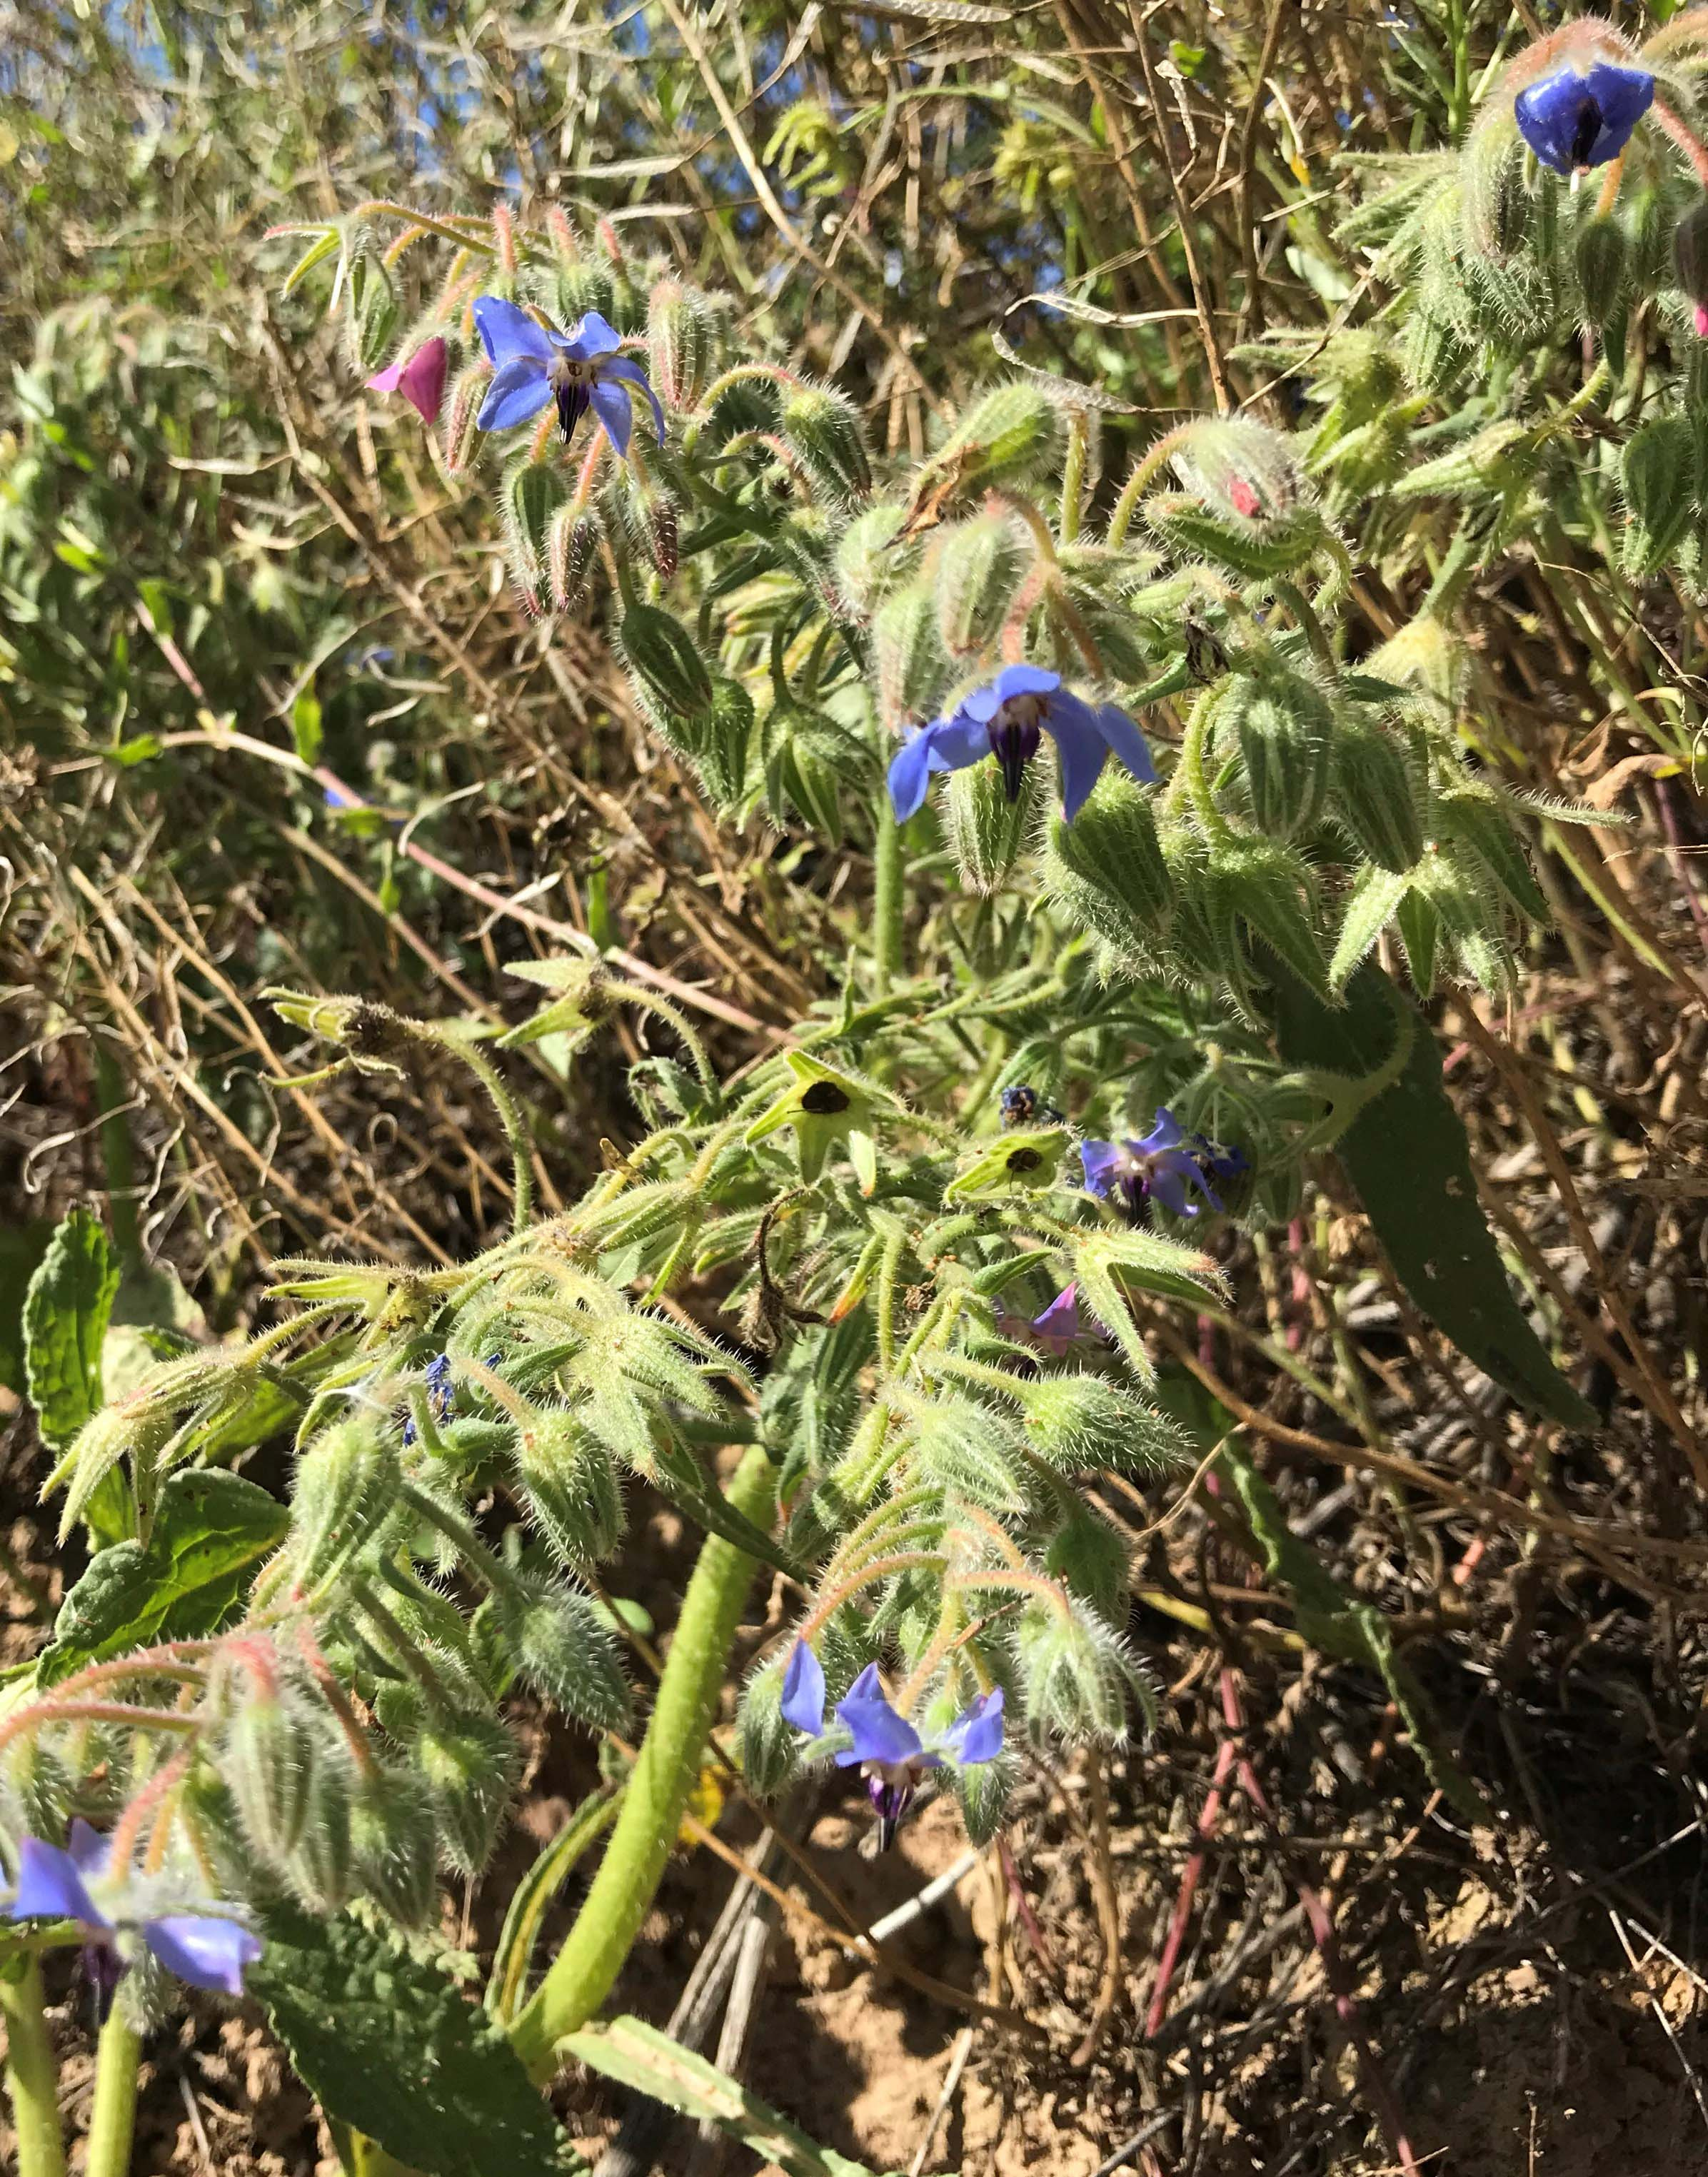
[248,1905,581,2177]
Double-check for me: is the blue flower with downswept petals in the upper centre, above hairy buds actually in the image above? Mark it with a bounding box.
[890,666,1157,823]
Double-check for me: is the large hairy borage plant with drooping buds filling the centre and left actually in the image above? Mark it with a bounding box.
[0,183,1601,2177]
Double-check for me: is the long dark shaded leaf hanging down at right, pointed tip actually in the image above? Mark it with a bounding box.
[1273,965,1597,1430]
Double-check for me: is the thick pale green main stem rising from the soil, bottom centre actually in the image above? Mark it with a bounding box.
[511,1446,777,2081]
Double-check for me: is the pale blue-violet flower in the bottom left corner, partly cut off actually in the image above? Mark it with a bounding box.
[2,1822,261,2009]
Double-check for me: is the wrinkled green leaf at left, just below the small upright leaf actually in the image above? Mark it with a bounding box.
[37,1467,289,1689]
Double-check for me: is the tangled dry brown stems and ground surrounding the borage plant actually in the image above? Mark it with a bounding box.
[0,0,1708,2177]
